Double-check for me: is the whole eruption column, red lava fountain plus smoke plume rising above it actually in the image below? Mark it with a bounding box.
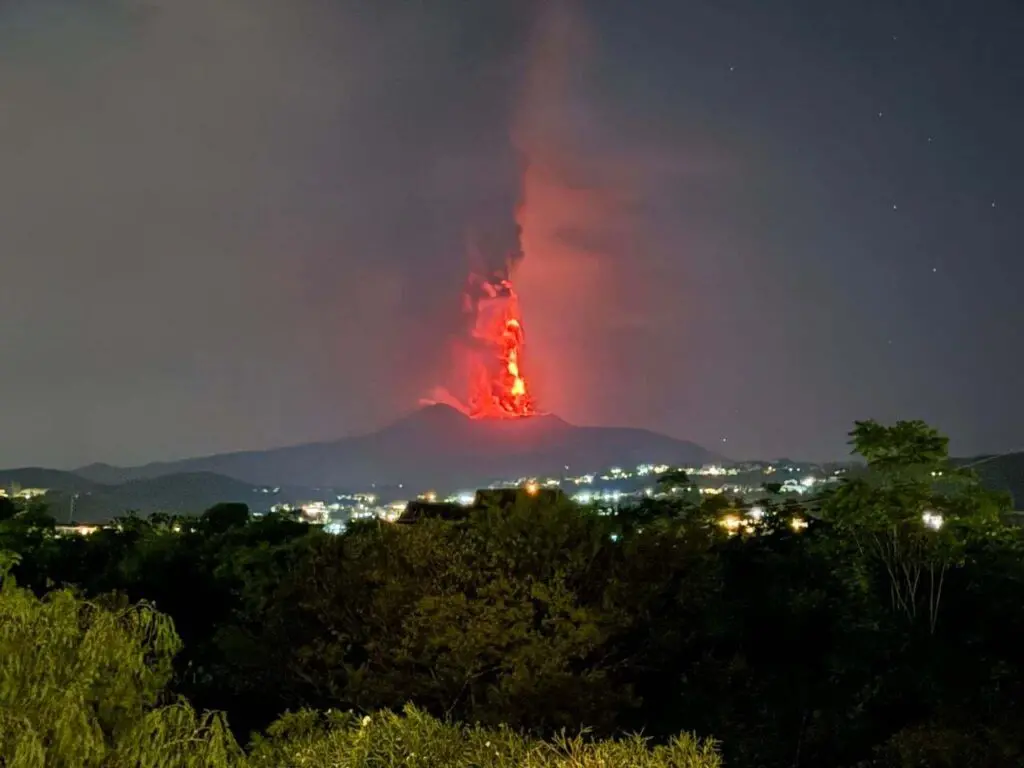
[433,0,606,415]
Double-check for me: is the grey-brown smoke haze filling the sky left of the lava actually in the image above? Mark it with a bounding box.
[0,0,526,465]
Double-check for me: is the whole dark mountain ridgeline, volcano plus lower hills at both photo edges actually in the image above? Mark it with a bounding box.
[0,406,1024,521]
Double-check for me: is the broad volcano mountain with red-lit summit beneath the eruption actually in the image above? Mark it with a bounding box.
[68,406,721,490]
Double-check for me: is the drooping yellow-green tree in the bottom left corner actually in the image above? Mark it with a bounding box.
[0,557,243,768]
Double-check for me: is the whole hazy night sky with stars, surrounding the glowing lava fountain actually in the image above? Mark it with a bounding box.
[0,0,1024,467]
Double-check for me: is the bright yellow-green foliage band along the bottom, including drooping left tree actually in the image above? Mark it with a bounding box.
[0,556,721,768]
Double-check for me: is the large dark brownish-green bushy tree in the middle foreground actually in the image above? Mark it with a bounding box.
[220,495,635,728]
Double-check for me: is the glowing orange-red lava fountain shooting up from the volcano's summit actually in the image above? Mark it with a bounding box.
[469,280,537,419]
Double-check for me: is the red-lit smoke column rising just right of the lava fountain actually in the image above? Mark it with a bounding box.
[513,0,679,423]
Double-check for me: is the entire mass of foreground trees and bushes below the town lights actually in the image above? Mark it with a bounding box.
[0,422,1024,768]
